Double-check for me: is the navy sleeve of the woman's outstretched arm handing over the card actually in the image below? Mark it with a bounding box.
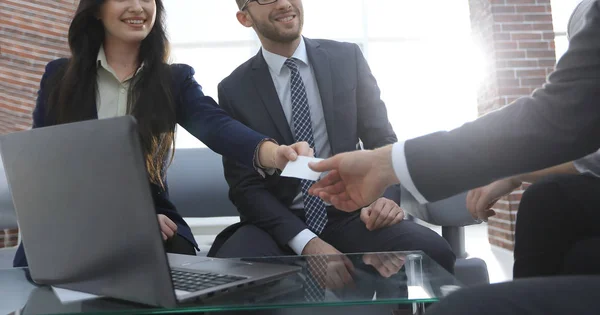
[173,65,267,168]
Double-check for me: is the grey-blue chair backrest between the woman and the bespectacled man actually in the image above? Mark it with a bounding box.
[167,148,239,217]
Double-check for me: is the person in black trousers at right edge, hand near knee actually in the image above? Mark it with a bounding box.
[467,151,600,279]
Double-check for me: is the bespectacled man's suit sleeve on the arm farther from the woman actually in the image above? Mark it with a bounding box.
[354,45,398,149]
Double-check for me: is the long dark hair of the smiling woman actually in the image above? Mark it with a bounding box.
[48,0,176,188]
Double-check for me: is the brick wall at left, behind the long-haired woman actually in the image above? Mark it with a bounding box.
[0,0,77,247]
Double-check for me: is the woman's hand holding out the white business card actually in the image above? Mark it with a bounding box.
[258,141,315,170]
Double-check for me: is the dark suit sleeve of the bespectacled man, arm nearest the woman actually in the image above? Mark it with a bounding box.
[218,84,307,246]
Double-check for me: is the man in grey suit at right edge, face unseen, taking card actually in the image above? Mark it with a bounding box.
[310,0,600,315]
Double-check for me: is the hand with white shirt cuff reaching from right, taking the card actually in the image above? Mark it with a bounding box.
[309,145,399,212]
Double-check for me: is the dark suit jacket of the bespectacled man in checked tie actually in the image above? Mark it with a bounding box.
[209,38,397,255]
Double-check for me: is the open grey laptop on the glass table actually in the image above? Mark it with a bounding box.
[0,116,301,307]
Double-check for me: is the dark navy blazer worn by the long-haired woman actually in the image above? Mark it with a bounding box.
[13,59,266,267]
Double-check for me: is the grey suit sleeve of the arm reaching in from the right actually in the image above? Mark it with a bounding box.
[404,1,600,201]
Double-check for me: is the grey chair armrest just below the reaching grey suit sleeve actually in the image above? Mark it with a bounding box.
[400,187,479,226]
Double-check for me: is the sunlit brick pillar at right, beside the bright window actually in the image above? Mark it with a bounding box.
[469,0,556,250]
